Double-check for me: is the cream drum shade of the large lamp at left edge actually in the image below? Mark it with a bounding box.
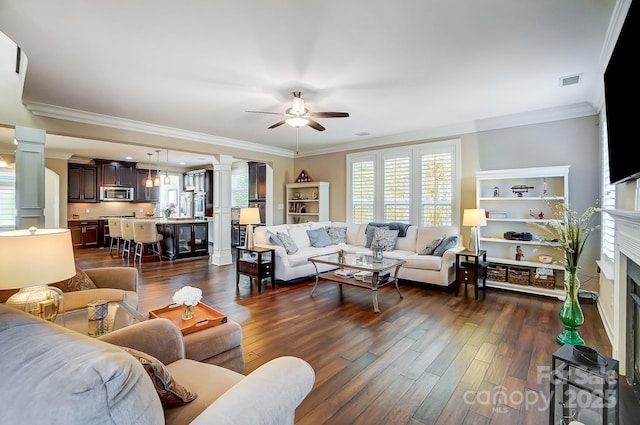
[0,227,76,289]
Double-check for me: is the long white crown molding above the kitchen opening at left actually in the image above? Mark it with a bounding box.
[25,101,294,158]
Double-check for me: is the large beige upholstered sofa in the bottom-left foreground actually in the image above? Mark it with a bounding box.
[0,305,315,425]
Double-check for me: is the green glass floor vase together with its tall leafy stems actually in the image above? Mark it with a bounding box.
[534,200,600,345]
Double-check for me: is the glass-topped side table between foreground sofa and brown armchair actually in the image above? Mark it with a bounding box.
[56,301,147,337]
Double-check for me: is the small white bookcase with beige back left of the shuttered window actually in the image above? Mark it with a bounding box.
[286,182,329,224]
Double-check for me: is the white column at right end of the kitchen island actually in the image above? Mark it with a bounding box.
[211,155,233,266]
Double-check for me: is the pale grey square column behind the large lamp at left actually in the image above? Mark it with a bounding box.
[16,127,46,229]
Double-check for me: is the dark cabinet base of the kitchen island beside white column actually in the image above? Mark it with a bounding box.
[157,221,209,260]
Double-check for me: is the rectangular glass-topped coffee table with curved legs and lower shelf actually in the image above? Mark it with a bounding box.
[309,252,405,313]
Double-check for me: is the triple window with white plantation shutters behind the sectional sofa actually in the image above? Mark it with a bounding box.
[347,139,460,226]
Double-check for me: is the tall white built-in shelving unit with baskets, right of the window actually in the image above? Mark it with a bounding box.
[476,166,569,299]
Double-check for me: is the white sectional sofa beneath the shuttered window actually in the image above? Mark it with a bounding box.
[254,221,464,287]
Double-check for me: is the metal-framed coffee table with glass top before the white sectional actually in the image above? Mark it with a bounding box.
[309,252,405,313]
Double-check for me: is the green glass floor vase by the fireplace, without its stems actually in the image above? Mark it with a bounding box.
[556,266,584,345]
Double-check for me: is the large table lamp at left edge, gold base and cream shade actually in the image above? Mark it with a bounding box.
[0,227,76,322]
